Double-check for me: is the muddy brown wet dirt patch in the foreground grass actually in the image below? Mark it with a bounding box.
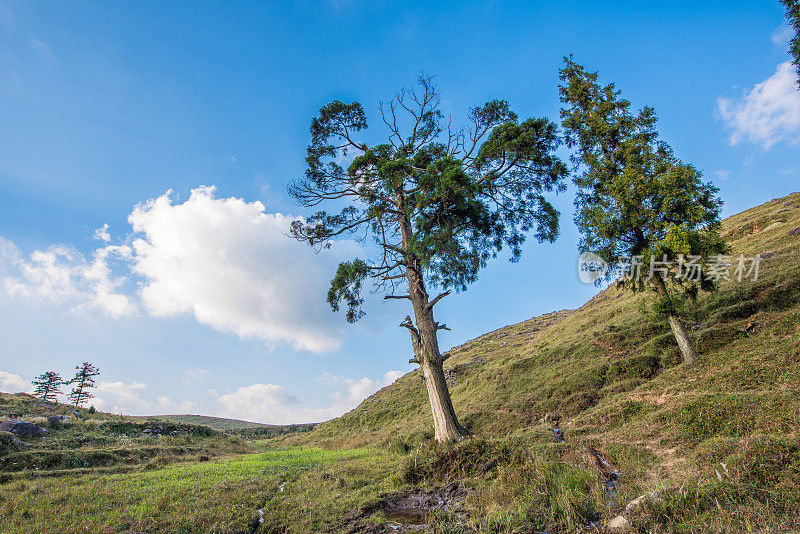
[343,480,468,534]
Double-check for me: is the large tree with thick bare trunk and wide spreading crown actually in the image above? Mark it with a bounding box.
[289,76,568,441]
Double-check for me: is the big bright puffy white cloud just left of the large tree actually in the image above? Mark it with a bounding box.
[129,187,357,352]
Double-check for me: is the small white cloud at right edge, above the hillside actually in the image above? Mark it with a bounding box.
[717,61,800,150]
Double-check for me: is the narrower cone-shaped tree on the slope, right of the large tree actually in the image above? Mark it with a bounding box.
[559,58,726,364]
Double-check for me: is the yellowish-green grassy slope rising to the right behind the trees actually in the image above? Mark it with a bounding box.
[280,193,800,530]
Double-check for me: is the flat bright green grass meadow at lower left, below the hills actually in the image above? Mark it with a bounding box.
[0,448,385,533]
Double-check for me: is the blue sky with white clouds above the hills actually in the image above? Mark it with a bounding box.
[0,0,800,423]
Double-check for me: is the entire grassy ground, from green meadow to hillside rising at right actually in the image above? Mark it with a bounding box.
[0,193,800,533]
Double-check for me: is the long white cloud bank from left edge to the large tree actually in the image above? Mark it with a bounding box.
[0,186,361,354]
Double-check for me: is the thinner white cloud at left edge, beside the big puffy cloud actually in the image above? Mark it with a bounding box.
[0,238,136,317]
